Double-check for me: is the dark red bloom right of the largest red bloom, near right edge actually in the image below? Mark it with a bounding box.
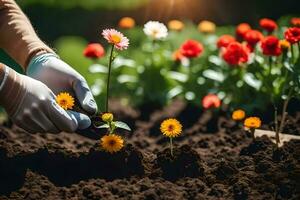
[261,36,281,56]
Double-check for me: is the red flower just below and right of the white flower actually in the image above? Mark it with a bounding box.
[180,40,203,58]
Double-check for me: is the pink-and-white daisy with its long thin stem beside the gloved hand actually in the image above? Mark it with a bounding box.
[102,29,129,112]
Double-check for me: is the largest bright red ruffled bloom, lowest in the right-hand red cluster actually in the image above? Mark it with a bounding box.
[222,42,250,65]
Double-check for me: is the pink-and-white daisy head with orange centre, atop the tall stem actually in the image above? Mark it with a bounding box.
[102,29,129,50]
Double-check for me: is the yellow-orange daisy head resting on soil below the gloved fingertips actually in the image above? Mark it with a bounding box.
[101,134,124,153]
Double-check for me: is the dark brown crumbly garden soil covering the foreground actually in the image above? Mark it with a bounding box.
[0,100,300,200]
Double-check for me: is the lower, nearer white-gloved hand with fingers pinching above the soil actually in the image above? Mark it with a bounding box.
[0,66,91,133]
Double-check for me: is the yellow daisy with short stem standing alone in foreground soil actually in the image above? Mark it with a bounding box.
[160,118,182,156]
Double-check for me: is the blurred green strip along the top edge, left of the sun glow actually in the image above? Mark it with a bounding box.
[17,0,148,10]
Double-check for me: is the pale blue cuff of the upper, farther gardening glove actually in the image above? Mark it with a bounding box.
[26,53,59,76]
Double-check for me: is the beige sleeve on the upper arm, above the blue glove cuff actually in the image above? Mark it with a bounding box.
[0,0,53,70]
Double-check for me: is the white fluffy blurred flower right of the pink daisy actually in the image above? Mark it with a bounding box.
[144,21,168,40]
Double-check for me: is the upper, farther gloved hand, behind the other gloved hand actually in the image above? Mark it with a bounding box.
[26,53,97,115]
